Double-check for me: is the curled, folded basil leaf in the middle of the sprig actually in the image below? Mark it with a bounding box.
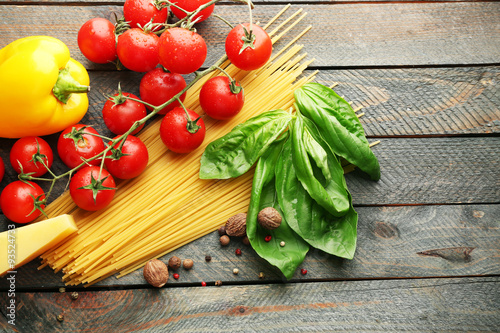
[291,112,349,216]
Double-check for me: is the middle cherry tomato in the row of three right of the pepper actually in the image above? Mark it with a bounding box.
[116,28,159,72]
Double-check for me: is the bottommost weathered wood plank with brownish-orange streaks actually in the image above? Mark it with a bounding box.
[0,278,500,333]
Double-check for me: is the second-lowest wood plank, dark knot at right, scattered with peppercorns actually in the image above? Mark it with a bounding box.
[0,205,500,291]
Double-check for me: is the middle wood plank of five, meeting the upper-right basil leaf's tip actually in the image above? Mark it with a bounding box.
[0,137,500,206]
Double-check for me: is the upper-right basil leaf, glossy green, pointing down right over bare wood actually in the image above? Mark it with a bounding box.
[294,83,380,180]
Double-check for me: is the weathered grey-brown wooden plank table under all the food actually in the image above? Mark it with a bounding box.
[0,0,500,332]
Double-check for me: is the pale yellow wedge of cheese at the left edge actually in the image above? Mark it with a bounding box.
[0,214,78,276]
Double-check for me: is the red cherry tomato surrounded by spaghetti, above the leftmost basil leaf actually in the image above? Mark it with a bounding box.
[200,76,245,120]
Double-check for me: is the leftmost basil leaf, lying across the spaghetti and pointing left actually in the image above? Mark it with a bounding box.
[199,110,292,179]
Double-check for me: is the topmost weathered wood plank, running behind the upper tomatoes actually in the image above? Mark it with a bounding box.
[0,2,500,68]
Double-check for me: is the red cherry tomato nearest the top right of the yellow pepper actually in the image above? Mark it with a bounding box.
[78,17,117,64]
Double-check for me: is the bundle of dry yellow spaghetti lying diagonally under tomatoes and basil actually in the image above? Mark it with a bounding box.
[40,7,316,285]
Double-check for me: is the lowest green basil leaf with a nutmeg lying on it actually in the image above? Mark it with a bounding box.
[247,136,309,279]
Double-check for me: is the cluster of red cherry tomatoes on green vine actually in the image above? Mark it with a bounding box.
[0,0,272,223]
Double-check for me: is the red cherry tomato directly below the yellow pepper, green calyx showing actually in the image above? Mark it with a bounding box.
[10,136,54,177]
